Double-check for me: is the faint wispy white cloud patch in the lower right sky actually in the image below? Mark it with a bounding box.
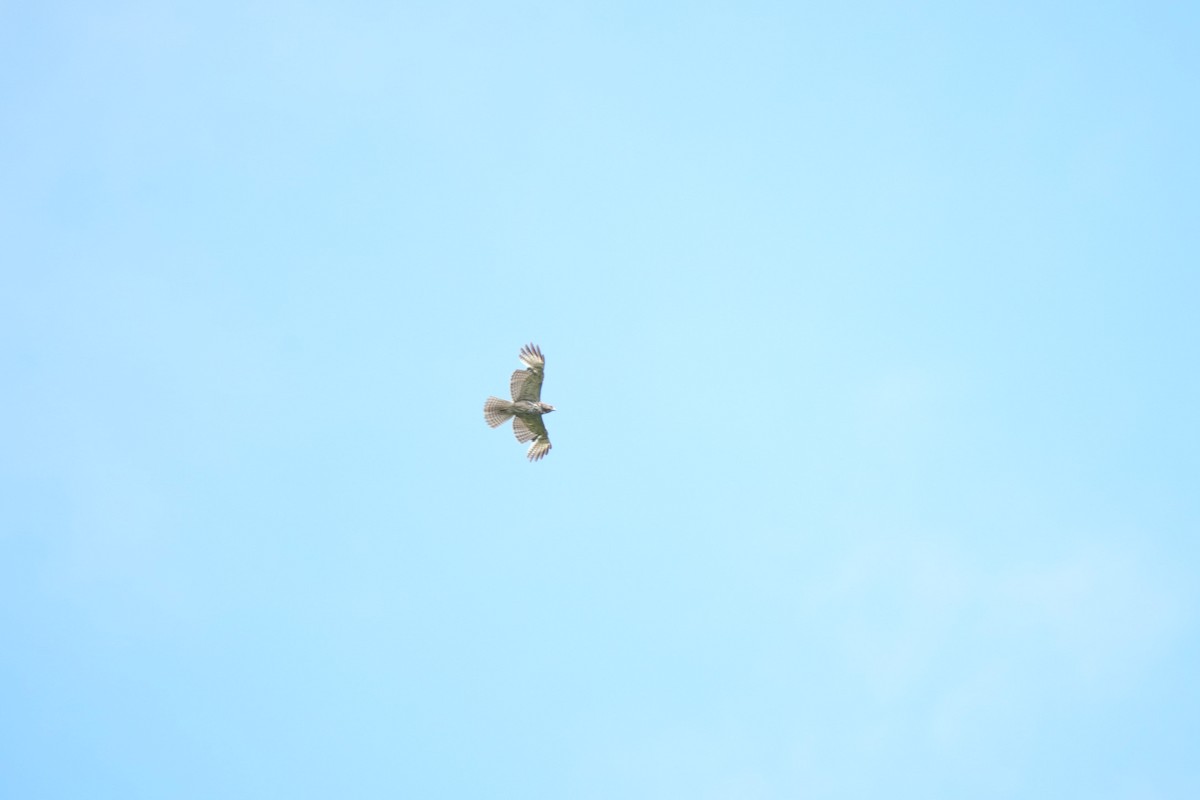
[815,542,1195,746]
